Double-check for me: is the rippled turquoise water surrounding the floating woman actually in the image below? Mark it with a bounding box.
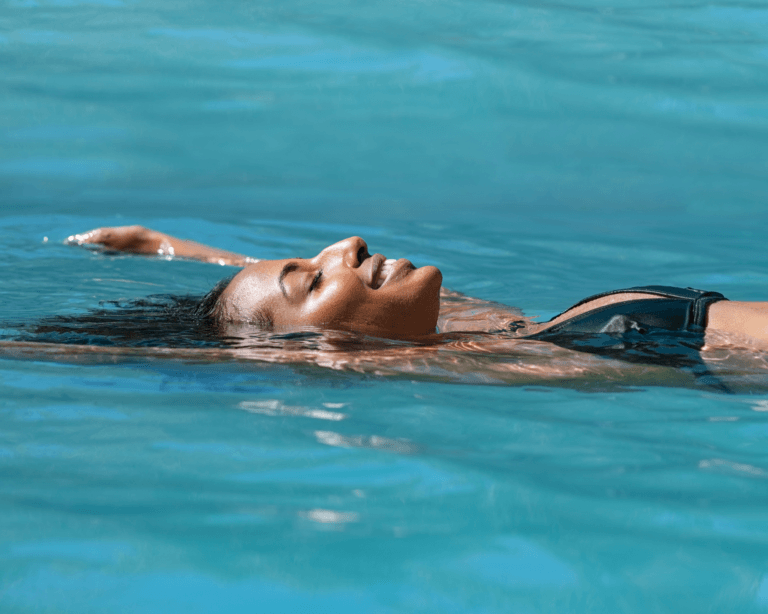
[0,0,768,614]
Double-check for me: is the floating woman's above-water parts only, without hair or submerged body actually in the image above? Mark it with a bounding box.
[69,226,768,347]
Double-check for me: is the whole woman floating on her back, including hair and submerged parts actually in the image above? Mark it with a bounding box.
[0,226,752,392]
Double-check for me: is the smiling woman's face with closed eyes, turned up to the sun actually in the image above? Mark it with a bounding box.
[219,237,442,338]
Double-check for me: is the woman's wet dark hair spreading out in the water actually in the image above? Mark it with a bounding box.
[4,277,240,347]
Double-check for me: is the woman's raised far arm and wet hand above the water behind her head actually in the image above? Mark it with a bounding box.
[67,226,258,267]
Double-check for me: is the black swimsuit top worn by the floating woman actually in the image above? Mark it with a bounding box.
[524,286,728,391]
